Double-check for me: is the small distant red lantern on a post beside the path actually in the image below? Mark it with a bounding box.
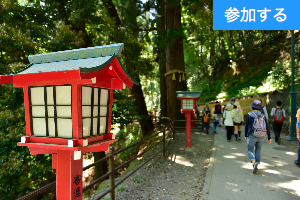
[176,91,201,148]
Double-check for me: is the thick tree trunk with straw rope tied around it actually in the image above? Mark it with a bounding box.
[166,0,187,119]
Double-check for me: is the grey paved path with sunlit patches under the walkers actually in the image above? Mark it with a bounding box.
[201,126,300,200]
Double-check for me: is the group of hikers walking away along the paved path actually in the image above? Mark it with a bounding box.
[202,97,290,174]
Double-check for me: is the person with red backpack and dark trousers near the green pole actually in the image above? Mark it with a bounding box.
[270,101,286,145]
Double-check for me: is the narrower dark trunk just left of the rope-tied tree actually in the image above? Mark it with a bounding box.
[157,0,168,116]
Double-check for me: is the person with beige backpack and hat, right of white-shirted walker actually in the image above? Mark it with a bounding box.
[232,102,244,141]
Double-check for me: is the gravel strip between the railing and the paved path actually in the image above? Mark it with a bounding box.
[94,127,214,200]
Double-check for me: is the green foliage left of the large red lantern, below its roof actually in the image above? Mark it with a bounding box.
[0,85,55,199]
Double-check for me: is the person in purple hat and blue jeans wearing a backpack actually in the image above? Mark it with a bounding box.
[245,100,272,174]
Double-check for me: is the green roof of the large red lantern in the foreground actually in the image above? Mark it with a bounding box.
[7,43,139,85]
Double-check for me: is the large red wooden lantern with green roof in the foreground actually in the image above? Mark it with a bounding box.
[0,43,138,200]
